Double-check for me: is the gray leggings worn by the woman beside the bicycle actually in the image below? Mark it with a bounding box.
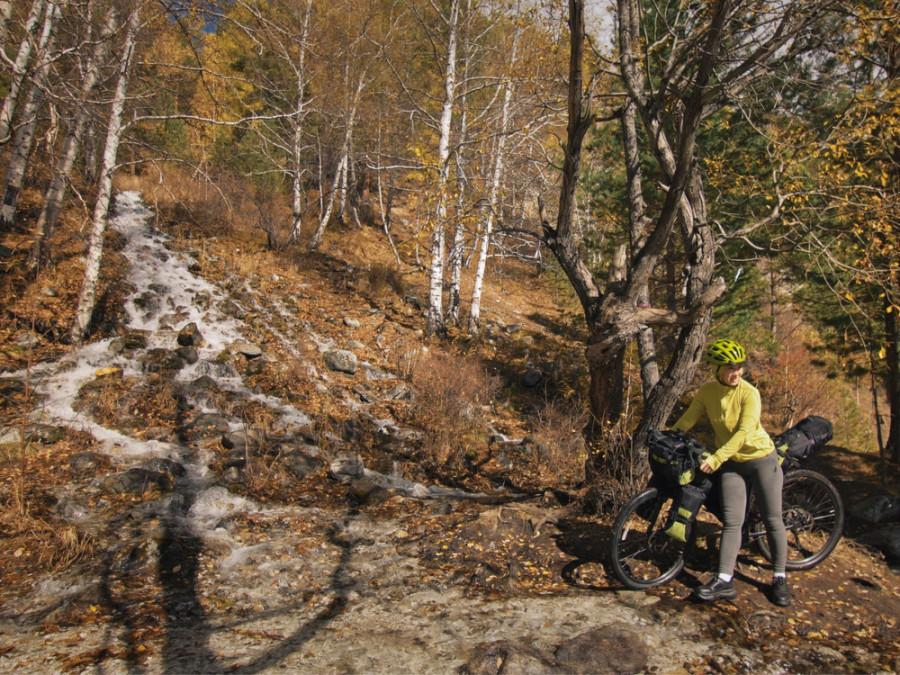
[719,452,787,574]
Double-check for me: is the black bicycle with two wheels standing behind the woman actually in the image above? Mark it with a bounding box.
[610,418,844,590]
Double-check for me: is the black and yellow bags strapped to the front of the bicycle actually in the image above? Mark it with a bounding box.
[647,431,712,541]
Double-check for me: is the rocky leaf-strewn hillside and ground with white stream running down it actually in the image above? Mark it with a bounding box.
[0,193,900,673]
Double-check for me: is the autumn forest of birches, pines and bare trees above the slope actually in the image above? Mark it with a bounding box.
[0,0,900,503]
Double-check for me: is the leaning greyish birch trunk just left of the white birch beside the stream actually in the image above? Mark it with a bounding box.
[29,6,119,269]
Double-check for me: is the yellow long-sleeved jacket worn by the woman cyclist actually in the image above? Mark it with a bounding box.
[672,379,775,471]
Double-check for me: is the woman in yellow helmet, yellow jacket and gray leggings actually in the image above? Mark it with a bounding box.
[672,340,791,607]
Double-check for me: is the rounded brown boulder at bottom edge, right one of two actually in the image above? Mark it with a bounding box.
[556,626,649,675]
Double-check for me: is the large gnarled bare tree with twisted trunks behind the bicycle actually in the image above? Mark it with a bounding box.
[545,0,848,496]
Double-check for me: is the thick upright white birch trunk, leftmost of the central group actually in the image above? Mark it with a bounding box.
[426,0,460,335]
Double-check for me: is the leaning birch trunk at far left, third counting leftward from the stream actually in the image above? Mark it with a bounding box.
[0,3,62,230]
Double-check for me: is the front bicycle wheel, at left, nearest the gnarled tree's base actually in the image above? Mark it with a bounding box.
[610,488,685,590]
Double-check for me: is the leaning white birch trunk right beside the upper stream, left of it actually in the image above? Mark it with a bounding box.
[71,8,140,342]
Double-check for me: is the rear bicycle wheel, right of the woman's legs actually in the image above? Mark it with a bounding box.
[751,469,844,570]
